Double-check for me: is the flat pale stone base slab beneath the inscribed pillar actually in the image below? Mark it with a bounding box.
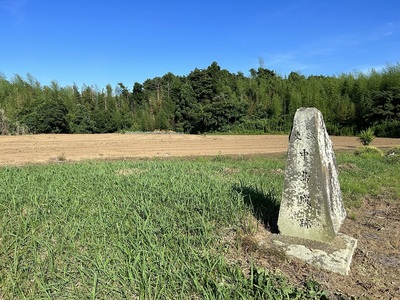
[271,233,357,275]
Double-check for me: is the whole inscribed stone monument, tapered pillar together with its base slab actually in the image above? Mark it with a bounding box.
[275,108,357,274]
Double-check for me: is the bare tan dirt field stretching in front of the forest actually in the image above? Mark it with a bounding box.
[0,134,400,165]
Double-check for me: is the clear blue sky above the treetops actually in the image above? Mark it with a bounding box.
[0,0,400,88]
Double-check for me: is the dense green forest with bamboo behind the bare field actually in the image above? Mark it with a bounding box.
[0,62,400,137]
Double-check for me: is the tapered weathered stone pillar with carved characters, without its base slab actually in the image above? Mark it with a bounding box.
[278,108,346,242]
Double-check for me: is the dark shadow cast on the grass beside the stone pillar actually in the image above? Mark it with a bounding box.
[234,183,280,233]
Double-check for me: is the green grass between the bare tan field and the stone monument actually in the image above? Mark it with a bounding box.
[0,154,400,299]
